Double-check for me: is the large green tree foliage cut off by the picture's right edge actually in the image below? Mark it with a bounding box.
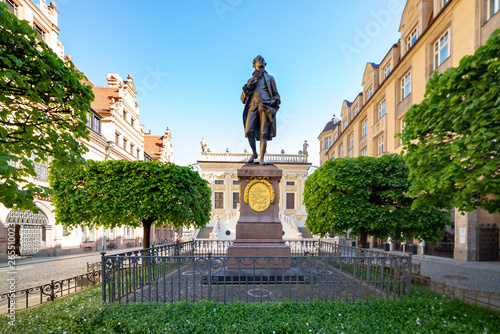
[401,30,500,213]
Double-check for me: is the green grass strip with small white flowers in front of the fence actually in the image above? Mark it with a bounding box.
[0,286,500,334]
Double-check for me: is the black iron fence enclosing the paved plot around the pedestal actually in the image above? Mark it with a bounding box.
[102,240,412,303]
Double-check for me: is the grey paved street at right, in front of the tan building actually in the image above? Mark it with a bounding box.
[413,255,500,293]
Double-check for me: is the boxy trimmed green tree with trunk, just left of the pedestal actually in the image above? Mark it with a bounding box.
[49,160,211,248]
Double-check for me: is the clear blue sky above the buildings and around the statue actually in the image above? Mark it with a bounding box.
[57,0,405,165]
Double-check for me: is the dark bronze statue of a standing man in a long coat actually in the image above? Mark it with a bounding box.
[241,56,281,165]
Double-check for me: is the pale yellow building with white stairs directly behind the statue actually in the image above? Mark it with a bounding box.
[190,140,313,240]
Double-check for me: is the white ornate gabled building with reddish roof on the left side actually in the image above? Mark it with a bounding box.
[0,0,176,261]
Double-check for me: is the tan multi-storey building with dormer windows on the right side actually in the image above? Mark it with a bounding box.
[318,0,500,261]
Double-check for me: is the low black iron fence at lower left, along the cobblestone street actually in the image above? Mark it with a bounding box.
[0,263,101,314]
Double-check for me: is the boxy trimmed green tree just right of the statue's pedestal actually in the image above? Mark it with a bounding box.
[304,154,449,247]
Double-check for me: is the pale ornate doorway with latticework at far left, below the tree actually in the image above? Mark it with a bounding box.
[7,210,47,255]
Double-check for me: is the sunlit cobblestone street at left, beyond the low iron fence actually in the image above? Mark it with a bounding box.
[0,248,141,294]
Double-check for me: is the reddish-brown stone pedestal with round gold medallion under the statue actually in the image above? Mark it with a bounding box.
[227,165,291,269]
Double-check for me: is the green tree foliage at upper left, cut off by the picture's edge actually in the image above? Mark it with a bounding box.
[0,3,94,212]
